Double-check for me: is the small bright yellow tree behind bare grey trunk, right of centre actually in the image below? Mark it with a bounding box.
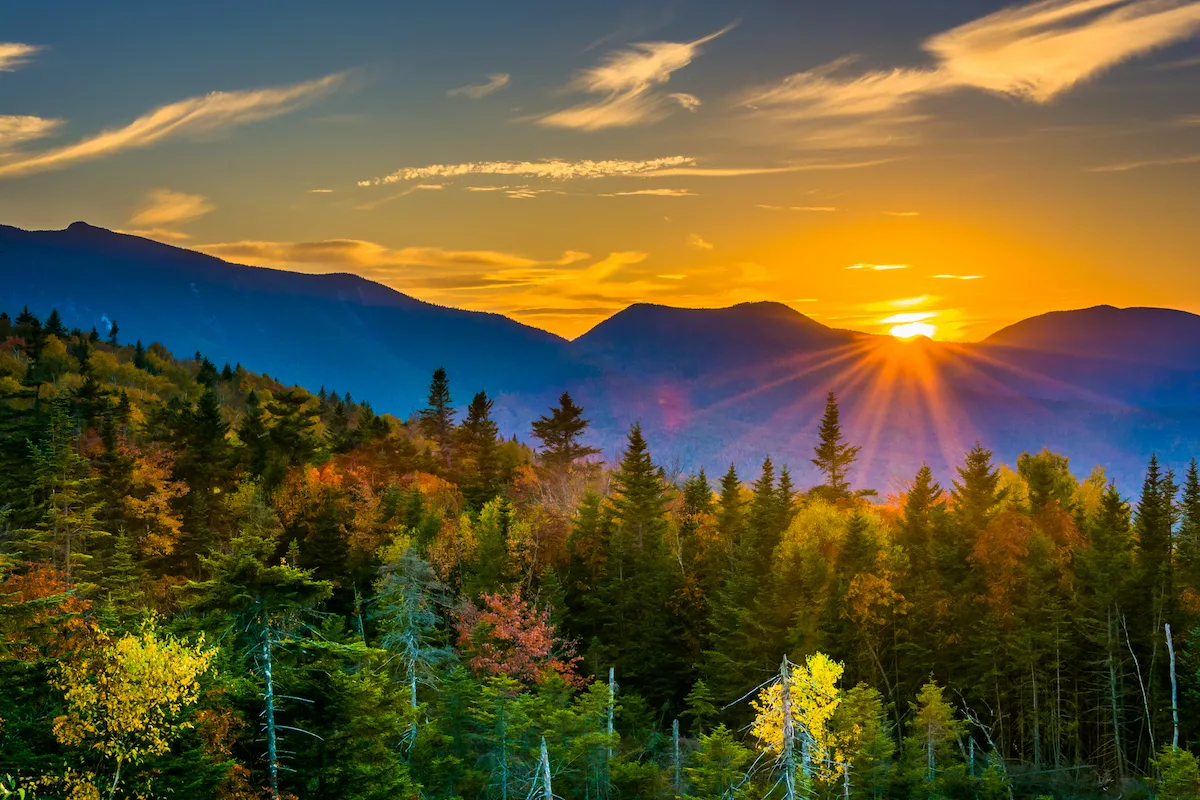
[750,652,844,782]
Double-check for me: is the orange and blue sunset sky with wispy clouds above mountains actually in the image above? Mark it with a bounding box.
[0,0,1200,341]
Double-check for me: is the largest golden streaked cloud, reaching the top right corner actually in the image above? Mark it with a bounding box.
[744,0,1200,130]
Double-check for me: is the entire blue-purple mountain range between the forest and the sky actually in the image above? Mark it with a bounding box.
[0,223,1200,492]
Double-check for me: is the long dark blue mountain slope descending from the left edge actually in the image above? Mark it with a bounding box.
[0,222,575,425]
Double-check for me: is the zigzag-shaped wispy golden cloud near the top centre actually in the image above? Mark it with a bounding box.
[536,23,736,131]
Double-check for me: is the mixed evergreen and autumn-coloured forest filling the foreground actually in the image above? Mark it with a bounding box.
[0,309,1200,800]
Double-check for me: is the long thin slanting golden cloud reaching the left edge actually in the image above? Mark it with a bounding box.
[0,73,346,179]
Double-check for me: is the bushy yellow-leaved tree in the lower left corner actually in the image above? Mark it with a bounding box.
[54,622,216,798]
